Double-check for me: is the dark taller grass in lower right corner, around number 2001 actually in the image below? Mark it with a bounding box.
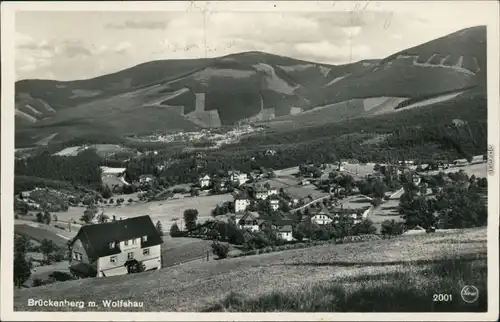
[204,258,487,312]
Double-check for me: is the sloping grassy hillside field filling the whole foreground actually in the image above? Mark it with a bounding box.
[14,228,487,312]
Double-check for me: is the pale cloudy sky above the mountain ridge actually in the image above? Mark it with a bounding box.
[15,3,484,81]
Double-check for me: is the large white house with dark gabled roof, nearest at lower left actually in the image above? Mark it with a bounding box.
[69,216,163,277]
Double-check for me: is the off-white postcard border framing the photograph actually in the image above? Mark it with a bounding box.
[0,1,500,321]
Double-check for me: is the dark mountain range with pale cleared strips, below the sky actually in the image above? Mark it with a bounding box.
[16,26,486,144]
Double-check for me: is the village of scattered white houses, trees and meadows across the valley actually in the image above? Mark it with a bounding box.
[12,151,486,287]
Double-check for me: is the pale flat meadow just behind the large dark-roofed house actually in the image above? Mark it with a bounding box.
[50,194,233,232]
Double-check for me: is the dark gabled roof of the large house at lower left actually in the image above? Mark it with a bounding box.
[71,216,163,260]
